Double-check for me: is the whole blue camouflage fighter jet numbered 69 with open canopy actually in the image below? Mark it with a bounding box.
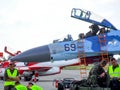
[11,8,120,62]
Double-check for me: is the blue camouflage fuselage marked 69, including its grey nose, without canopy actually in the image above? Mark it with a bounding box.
[11,30,120,62]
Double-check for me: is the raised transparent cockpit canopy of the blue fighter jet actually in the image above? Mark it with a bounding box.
[71,8,117,30]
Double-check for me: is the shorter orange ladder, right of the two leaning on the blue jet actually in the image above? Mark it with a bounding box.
[98,34,109,62]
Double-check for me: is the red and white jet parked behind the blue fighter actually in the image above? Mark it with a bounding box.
[0,46,80,81]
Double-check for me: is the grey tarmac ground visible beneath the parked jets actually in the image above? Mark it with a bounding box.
[0,70,88,90]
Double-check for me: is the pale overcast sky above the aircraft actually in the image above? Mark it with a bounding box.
[0,0,120,55]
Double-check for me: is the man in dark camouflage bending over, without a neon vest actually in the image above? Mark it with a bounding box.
[87,60,109,87]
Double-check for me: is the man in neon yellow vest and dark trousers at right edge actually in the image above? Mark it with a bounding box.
[107,58,120,90]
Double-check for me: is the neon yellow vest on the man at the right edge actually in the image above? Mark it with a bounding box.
[108,65,120,78]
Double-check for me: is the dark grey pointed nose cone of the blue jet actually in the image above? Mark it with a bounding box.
[11,45,50,62]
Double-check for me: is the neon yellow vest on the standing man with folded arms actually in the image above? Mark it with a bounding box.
[4,68,17,86]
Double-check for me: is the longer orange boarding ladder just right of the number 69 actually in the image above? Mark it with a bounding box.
[77,33,87,79]
